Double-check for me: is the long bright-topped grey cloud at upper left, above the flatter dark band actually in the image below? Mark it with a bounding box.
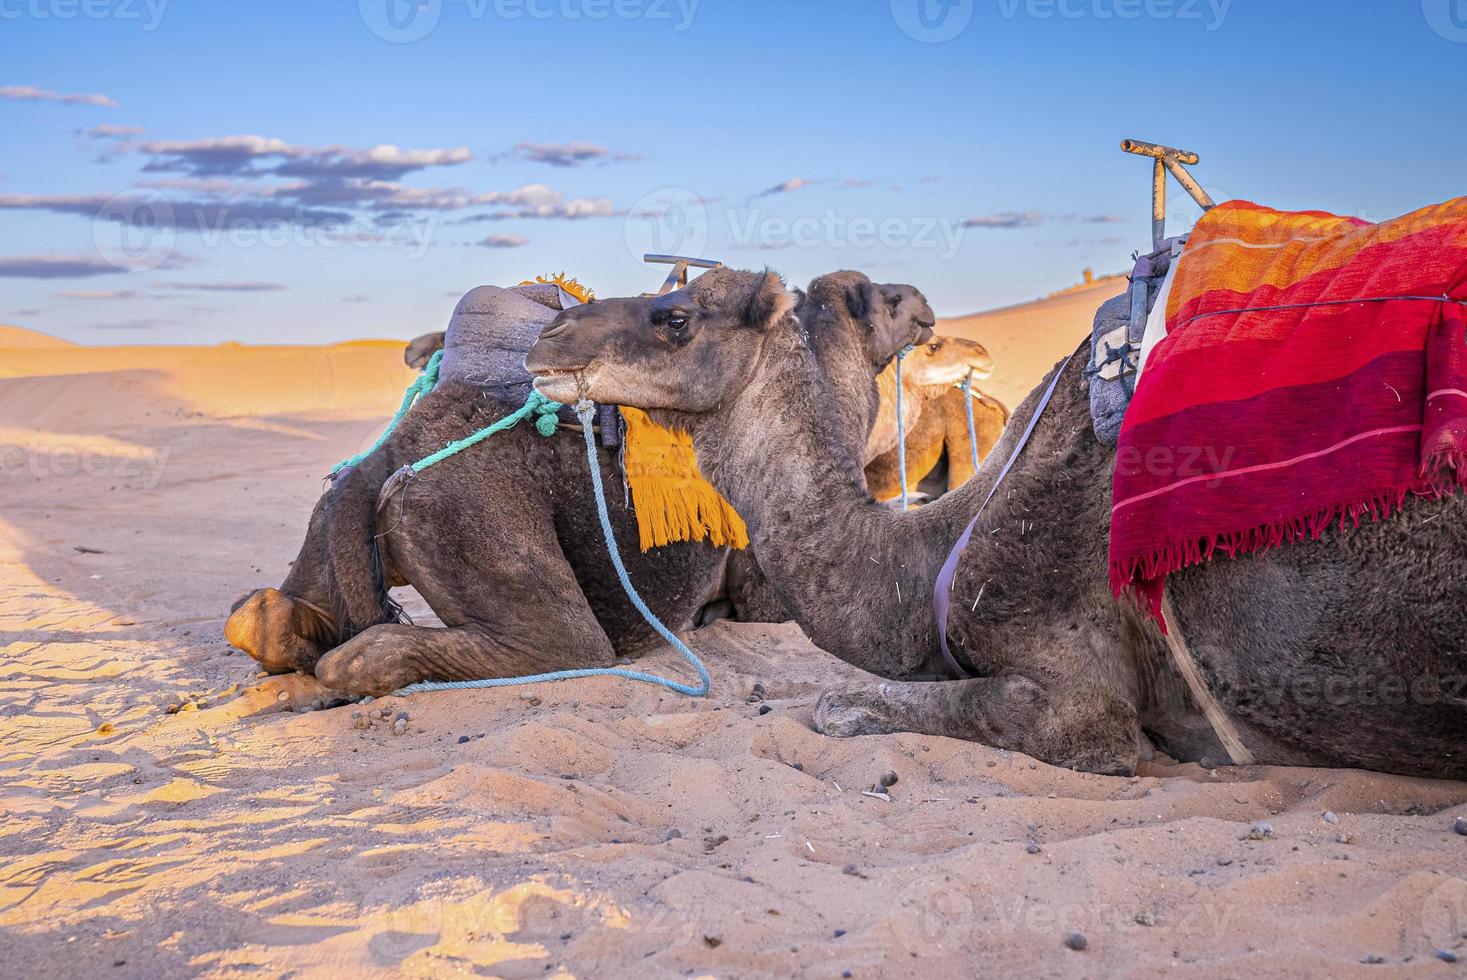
[138,135,474,180]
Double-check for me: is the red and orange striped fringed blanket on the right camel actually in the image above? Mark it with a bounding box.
[1111,198,1467,618]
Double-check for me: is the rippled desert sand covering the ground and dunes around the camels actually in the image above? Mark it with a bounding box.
[0,315,1467,979]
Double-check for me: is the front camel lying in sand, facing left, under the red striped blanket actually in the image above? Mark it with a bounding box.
[525,270,1467,779]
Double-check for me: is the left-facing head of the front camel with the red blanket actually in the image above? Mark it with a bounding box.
[525,268,795,414]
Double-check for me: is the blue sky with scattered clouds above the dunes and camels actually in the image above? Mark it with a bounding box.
[0,0,1467,345]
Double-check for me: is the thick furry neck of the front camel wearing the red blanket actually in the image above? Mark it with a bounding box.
[691,330,964,676]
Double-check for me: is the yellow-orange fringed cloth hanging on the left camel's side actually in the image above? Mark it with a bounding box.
[621,408,748,552]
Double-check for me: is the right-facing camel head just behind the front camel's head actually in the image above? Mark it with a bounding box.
[800,271,936,371]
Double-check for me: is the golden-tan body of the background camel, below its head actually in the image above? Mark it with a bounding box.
[866,384,1009,500]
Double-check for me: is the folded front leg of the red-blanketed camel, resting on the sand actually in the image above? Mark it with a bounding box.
[814,675,1141,775]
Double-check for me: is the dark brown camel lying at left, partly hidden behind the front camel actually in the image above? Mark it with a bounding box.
[226,273,932,695]
